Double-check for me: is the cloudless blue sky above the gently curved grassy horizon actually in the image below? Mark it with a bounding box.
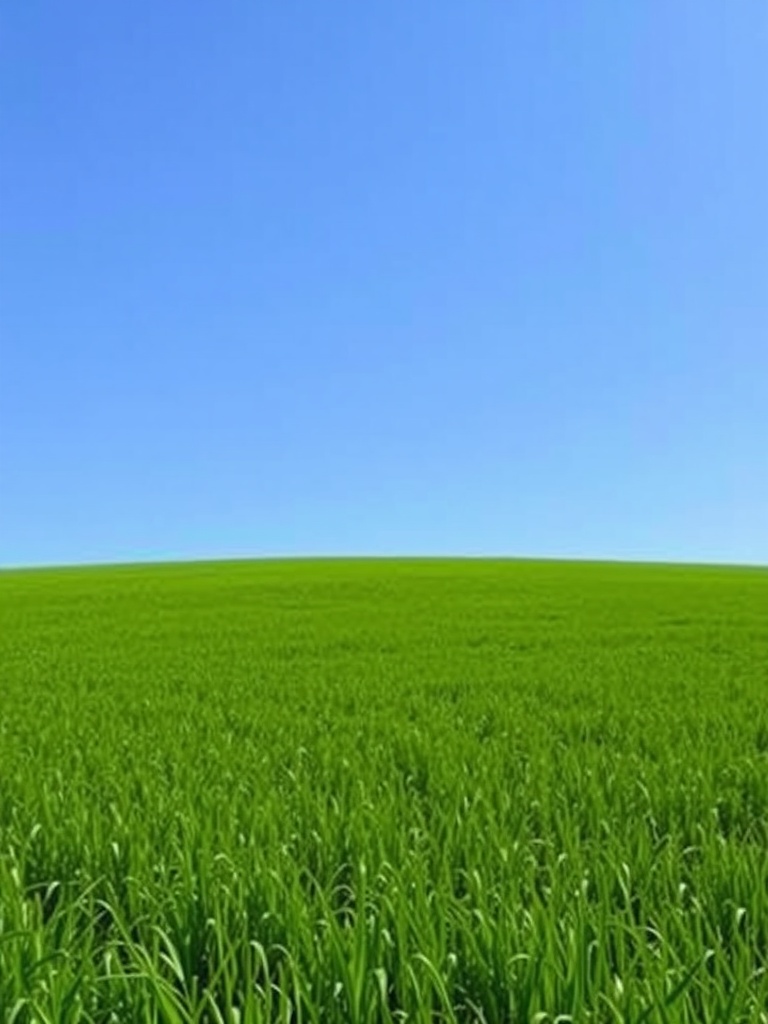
[0,0,768,565]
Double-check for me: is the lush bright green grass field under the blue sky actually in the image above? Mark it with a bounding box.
[0,560,768,1024]
